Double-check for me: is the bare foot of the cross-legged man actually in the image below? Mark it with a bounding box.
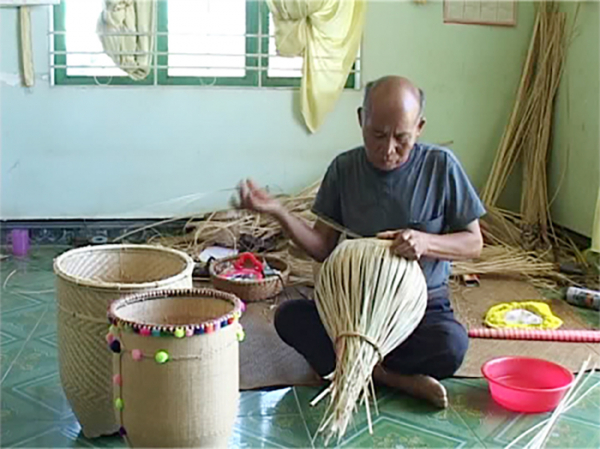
[373,366,448,408]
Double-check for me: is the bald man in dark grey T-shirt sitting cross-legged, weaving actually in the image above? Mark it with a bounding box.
[240,76,485,407]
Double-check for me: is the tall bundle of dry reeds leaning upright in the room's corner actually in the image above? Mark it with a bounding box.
[482,1,566,249]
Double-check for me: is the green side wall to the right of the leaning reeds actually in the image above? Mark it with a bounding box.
[549,2,600,237]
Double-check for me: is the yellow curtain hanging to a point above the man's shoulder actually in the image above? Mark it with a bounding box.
[267,0,366,132]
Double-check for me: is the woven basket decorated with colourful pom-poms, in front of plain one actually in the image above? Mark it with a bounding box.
[105,289,243,448]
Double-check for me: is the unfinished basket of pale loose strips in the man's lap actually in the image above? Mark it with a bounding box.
[313,239,427,441]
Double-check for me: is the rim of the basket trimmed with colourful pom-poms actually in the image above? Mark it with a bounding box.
[107,288,246,335]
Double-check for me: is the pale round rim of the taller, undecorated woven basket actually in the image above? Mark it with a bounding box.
[53,243,194,291]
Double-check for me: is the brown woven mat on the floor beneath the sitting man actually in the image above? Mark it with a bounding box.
[232,278,600,390]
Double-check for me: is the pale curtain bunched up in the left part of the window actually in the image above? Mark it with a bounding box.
[97,0,156,81]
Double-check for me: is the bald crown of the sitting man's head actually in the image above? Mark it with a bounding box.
[363,76,425,119]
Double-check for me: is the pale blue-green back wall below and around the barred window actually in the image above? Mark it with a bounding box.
[0,1,533,219]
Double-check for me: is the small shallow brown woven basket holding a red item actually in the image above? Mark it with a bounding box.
[209,256,290,302]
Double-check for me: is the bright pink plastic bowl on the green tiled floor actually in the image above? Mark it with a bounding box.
[481,357,573,413]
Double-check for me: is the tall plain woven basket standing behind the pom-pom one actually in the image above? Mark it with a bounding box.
[54,245,194,438]
